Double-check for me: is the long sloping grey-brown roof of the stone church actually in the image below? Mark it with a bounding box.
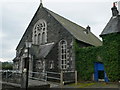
[45,8,102,46]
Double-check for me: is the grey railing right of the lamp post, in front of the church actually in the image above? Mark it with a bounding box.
[29,71,77,84]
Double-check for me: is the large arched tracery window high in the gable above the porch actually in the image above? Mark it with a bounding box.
[33,20,47,44]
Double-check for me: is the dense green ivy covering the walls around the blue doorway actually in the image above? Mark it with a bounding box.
[74,34,120,81]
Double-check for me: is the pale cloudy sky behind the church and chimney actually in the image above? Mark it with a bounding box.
[0,0,120,62]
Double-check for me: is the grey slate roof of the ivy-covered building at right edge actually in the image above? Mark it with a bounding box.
[100,15,120,36]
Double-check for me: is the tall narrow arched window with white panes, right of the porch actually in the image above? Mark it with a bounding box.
[59,40,67,70]
